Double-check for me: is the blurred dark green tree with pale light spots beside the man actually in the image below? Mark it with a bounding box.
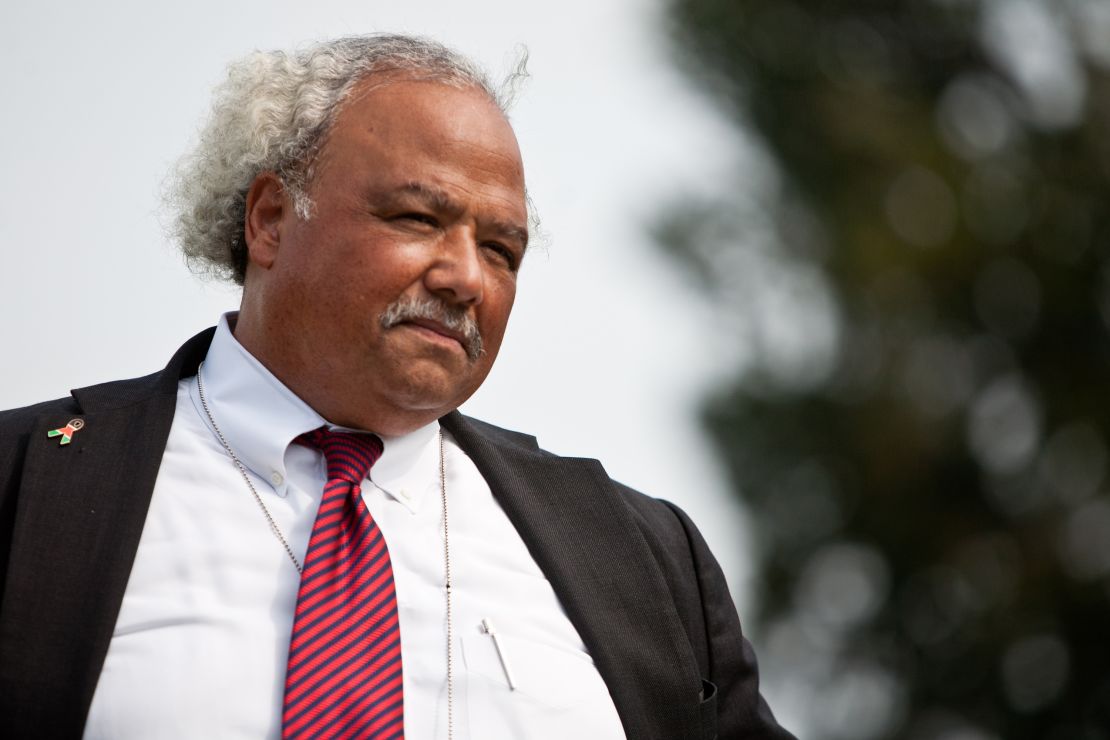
[658,0,1110,740]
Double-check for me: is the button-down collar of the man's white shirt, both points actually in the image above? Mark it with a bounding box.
[190,312,440,513]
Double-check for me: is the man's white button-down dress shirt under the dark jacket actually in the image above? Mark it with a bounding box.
[84,314,625,740]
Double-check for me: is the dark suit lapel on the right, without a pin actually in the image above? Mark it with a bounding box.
[442,413,702,739]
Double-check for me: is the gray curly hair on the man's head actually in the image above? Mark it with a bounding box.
[165,33,527,285]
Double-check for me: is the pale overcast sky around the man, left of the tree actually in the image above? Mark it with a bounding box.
[0,0,747,596]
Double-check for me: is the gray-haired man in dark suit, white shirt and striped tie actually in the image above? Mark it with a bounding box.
[0,36,789,740]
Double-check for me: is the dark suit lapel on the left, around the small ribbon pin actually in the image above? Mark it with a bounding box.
[0,332,211,737]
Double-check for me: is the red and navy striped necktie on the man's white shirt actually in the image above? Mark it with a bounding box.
[282,427,404,740]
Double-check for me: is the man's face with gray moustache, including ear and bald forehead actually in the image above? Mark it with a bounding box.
[235,81,527,435]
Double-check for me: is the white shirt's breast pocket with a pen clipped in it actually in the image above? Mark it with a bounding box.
[461,631,625,740]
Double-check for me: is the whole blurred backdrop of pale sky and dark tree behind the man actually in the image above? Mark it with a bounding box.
[0,0,1110,740]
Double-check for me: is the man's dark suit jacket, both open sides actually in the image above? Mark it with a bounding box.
[0,330,790,740]
